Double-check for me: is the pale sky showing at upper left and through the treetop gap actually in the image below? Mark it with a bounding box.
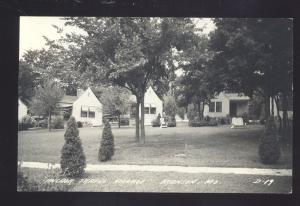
[19,16,215,57]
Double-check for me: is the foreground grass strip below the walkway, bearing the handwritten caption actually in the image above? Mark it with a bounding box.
[18,168,292,193]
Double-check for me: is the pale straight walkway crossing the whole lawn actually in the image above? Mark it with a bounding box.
[18,162,292,176]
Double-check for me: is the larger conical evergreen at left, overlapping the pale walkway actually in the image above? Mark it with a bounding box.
[60,117,86,177]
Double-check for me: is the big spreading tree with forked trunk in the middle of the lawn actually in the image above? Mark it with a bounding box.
[59,17,194,143]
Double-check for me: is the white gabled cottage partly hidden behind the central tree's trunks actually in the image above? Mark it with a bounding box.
[130,86,163,125]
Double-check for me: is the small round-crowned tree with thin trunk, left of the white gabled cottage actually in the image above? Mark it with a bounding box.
[30,80,63,131]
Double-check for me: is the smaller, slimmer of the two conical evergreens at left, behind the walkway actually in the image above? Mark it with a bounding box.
[98,120,115,162]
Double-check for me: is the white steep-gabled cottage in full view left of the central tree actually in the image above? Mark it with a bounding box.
[72,88,102,126]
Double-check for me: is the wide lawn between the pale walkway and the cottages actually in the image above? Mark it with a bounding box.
[18,125,292,168]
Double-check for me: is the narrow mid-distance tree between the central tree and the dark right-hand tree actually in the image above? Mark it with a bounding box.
[175,35,214,119]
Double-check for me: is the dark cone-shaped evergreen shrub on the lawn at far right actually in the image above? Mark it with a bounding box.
[259,116,281,164]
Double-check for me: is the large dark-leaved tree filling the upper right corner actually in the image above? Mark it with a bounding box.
[210,18,293,135]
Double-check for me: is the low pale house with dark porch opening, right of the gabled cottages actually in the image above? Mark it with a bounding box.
[203,92,250,117]
